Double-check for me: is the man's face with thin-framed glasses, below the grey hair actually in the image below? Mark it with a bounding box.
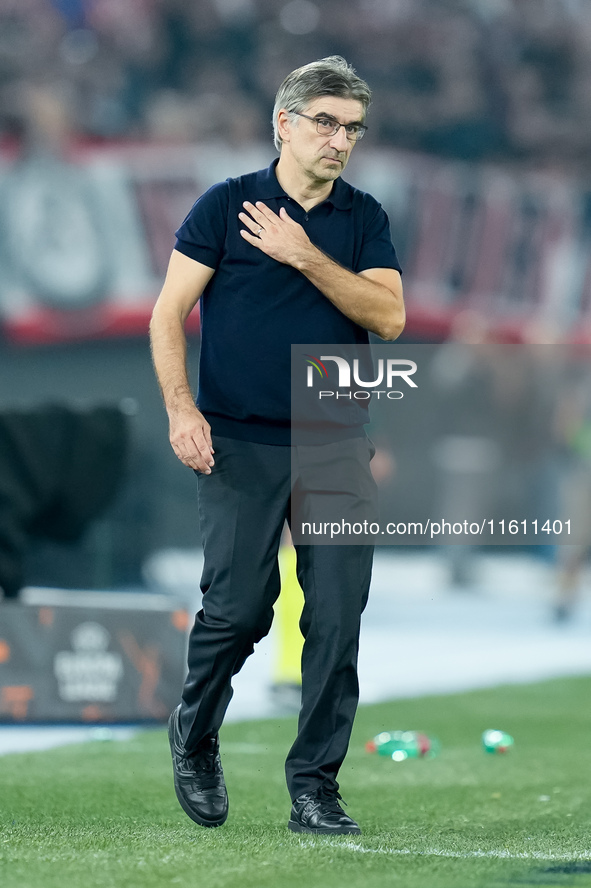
[282,96,363,182]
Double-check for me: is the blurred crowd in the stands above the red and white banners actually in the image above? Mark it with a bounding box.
[0,0,591,164]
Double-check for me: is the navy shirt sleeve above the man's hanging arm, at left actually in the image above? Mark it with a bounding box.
[174,182,229,268]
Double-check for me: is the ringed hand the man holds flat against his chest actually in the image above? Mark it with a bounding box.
[238,200,315,268]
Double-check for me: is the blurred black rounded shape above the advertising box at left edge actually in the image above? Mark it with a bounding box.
[0,404,129,598]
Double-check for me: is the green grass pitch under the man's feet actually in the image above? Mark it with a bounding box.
[0,677,591,888]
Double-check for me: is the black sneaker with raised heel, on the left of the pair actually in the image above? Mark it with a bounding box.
[168,705,228,826]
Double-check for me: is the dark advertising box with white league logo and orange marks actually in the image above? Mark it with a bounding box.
[0,590,188,723]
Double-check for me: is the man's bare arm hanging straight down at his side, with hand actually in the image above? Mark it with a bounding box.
[150,250,214,475]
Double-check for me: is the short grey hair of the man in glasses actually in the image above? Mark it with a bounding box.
[273,56,371,151]
